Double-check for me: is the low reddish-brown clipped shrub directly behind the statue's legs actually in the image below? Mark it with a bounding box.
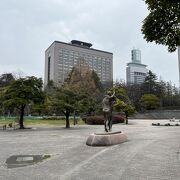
[82,114,125,125]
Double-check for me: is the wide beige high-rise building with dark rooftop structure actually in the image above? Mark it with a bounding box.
[44,40,113,86]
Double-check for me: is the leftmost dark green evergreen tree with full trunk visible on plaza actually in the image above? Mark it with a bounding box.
[3,76,44,129]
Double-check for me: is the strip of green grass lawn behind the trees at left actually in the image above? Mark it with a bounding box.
[0,119,85,126]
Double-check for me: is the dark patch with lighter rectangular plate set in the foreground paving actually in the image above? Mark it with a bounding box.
[6,155,50,168]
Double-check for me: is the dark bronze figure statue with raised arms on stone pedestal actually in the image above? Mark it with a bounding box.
[102,91,116,132]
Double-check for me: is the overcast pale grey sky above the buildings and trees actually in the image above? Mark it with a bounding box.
[0,0,178,85]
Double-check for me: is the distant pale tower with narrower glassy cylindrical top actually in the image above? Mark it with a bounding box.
[126,49,148,84]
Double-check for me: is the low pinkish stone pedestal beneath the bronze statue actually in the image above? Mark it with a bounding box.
[86,131,127,146]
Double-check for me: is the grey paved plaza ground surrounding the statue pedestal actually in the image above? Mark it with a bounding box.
[0,120,180,180]
